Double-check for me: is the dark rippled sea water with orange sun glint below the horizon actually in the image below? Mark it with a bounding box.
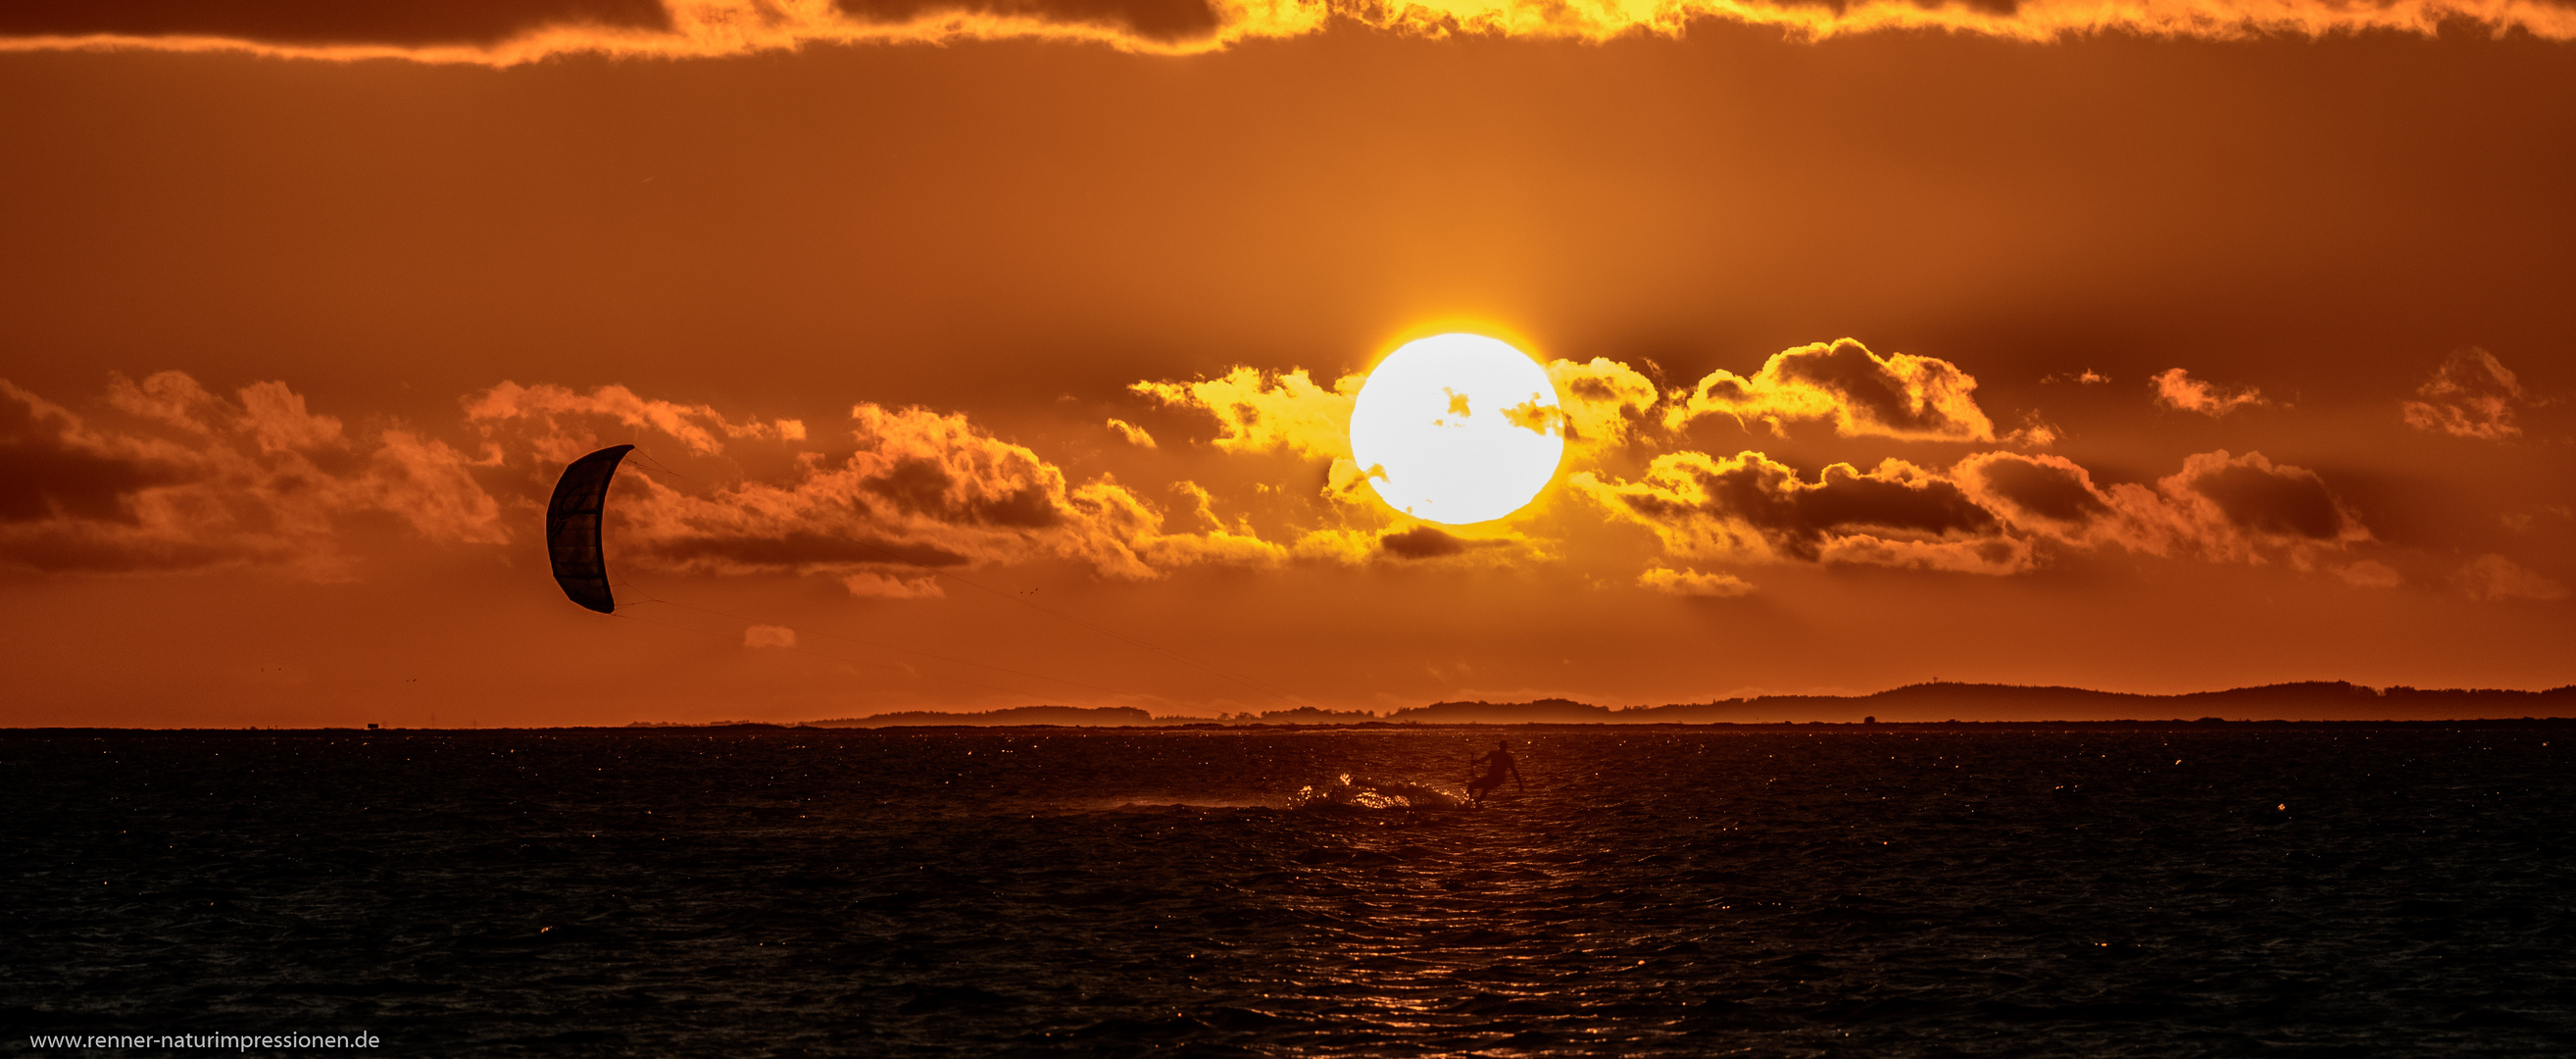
[0,724,2576,1056]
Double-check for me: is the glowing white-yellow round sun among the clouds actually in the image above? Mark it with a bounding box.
[1350,335,1566,526]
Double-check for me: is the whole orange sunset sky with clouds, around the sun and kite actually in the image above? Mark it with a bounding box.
[0,0,2576,727]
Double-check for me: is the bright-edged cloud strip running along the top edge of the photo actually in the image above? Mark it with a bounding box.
[0,0,2576,65]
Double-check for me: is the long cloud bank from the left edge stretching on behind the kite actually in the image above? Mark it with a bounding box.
[0,371,1291,598]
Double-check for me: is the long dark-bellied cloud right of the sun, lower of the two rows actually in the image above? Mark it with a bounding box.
[1571,451,2393,580]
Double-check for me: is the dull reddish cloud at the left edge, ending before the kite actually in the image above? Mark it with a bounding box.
[0,371,508,578]
